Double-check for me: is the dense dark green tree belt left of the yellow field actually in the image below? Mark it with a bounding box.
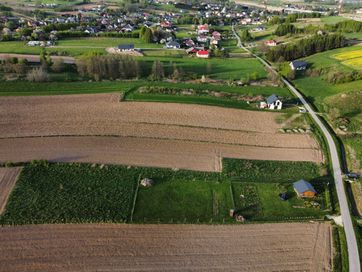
[266,34,346,62]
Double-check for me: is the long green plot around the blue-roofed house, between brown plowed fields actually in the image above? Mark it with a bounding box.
[0,159,330,224]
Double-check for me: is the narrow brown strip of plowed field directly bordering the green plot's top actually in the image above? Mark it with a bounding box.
[0,137,323,172]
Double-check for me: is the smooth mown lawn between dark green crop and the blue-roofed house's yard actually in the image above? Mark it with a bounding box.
[133,178,232,223]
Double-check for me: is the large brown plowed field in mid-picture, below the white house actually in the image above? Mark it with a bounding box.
[0,94,323,171]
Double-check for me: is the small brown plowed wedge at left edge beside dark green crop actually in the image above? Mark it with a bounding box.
[0,167,21,214]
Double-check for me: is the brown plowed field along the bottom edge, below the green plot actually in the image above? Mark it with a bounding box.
[0,223,332,272]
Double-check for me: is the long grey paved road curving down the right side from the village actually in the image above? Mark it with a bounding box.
[232,26,361,272]
